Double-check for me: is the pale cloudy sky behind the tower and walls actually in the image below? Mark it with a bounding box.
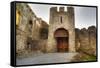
[28,4,96,29]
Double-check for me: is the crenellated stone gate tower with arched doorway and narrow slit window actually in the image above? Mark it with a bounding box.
[46,7,75,52]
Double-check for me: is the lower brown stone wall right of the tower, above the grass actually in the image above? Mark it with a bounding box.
[75,26,96,55]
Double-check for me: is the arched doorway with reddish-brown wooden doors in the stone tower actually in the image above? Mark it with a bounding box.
[54,28,69,52]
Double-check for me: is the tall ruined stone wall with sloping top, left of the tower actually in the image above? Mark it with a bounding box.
[16,3,48,54]
